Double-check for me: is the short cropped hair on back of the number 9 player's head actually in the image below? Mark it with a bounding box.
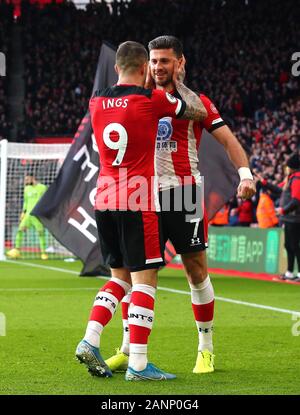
[116,41,148,72]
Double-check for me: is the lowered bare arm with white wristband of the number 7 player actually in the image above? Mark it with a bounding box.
[211,125,256,199]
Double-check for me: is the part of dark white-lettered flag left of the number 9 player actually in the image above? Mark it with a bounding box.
[32,43,117,275]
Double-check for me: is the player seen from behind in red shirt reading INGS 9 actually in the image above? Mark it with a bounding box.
[76,41,207,381]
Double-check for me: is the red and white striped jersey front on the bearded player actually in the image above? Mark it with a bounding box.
[156,92,225,190]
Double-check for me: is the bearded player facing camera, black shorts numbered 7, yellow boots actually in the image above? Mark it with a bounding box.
[106,35,255,374]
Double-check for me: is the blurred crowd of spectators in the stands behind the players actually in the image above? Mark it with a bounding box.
[0,0,300,226]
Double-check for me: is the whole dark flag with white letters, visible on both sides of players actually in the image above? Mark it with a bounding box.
[32,43,239,275]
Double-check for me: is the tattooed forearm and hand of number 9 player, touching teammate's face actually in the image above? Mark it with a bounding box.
[173,57,207,121]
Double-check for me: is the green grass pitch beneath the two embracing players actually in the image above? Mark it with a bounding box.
[0,261,300,395]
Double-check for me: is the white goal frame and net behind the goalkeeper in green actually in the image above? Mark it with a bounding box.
[0,140,73,260]
